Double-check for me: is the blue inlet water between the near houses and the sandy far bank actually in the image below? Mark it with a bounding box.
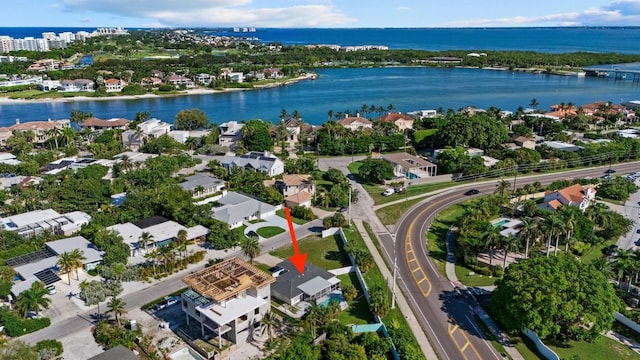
[0,68,640,126]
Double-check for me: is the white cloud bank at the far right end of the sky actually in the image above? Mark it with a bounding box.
[444,0,640,27]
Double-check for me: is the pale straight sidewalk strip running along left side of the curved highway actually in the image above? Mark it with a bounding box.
[353,219,438,359]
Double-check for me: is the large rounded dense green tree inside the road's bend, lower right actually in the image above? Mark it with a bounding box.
[491,254,621,343]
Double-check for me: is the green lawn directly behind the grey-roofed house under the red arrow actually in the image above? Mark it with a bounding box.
[269,235,351,270]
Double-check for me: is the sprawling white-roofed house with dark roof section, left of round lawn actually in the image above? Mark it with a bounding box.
[107,216,209,256]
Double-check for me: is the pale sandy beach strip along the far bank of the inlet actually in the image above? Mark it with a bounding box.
[0,73,317,105]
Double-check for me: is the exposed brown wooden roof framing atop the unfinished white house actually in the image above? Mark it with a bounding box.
[182,257,276,302]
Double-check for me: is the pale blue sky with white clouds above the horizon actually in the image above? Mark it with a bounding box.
[0,0,640,28]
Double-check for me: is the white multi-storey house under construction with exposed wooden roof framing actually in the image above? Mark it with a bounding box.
[182,257,275,349]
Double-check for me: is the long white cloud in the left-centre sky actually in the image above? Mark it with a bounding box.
[62,0,355,27]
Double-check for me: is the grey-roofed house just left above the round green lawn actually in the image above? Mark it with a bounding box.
[211,191,277,229]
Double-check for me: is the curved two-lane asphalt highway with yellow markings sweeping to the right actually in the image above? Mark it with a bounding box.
[380,163,640,360]
